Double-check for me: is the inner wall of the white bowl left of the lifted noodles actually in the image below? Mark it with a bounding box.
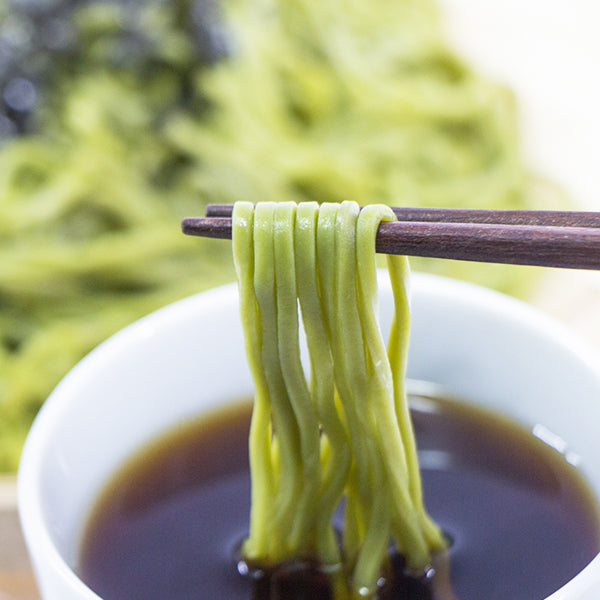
[33,287,252,566]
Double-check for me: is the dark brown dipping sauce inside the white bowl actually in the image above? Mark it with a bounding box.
[78,396,600,600]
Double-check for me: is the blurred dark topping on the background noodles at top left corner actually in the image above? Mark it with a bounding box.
[0,0,227,140]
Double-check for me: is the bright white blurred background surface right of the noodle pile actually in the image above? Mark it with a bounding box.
[438,0,600,350]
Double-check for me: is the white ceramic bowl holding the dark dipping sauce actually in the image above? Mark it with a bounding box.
[18,274,600,600]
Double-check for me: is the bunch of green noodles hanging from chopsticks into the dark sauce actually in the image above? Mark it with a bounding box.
[233,201,445,597]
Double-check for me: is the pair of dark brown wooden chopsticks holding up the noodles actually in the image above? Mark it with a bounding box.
[181,204,600,269]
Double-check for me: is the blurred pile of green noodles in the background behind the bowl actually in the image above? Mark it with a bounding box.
[0,0,561,471]
